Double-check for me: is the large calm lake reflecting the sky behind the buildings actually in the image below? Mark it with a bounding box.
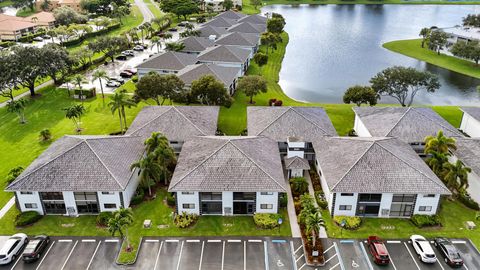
[262,5,480,105]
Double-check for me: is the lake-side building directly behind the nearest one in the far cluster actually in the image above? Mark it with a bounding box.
[197,45,250,76]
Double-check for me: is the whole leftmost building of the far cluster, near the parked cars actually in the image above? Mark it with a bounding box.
[136,51,197,78]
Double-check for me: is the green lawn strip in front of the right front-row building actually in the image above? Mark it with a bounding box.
[323,200,480,247]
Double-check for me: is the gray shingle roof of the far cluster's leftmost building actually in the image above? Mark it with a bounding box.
[137,52,197,71]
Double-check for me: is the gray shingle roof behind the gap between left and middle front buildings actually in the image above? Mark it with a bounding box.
[126,106,219,142]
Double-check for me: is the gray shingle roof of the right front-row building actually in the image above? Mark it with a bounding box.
[313,137,450,195]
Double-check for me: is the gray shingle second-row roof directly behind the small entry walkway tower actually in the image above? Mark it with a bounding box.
[247,106,337,142]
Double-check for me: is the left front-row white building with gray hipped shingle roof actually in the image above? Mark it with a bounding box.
[6,136,144,216]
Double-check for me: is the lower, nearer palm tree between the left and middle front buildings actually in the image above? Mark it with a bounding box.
[130,153,162,196]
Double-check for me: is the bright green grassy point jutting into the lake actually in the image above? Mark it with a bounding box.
[383,39,480,78]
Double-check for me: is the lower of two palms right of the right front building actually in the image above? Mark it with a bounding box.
[443,160,472,192]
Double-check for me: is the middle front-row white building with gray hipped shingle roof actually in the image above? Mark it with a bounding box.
[168,136,287,215]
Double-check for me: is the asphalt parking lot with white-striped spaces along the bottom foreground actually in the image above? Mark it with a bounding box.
[0,236,480,270]
